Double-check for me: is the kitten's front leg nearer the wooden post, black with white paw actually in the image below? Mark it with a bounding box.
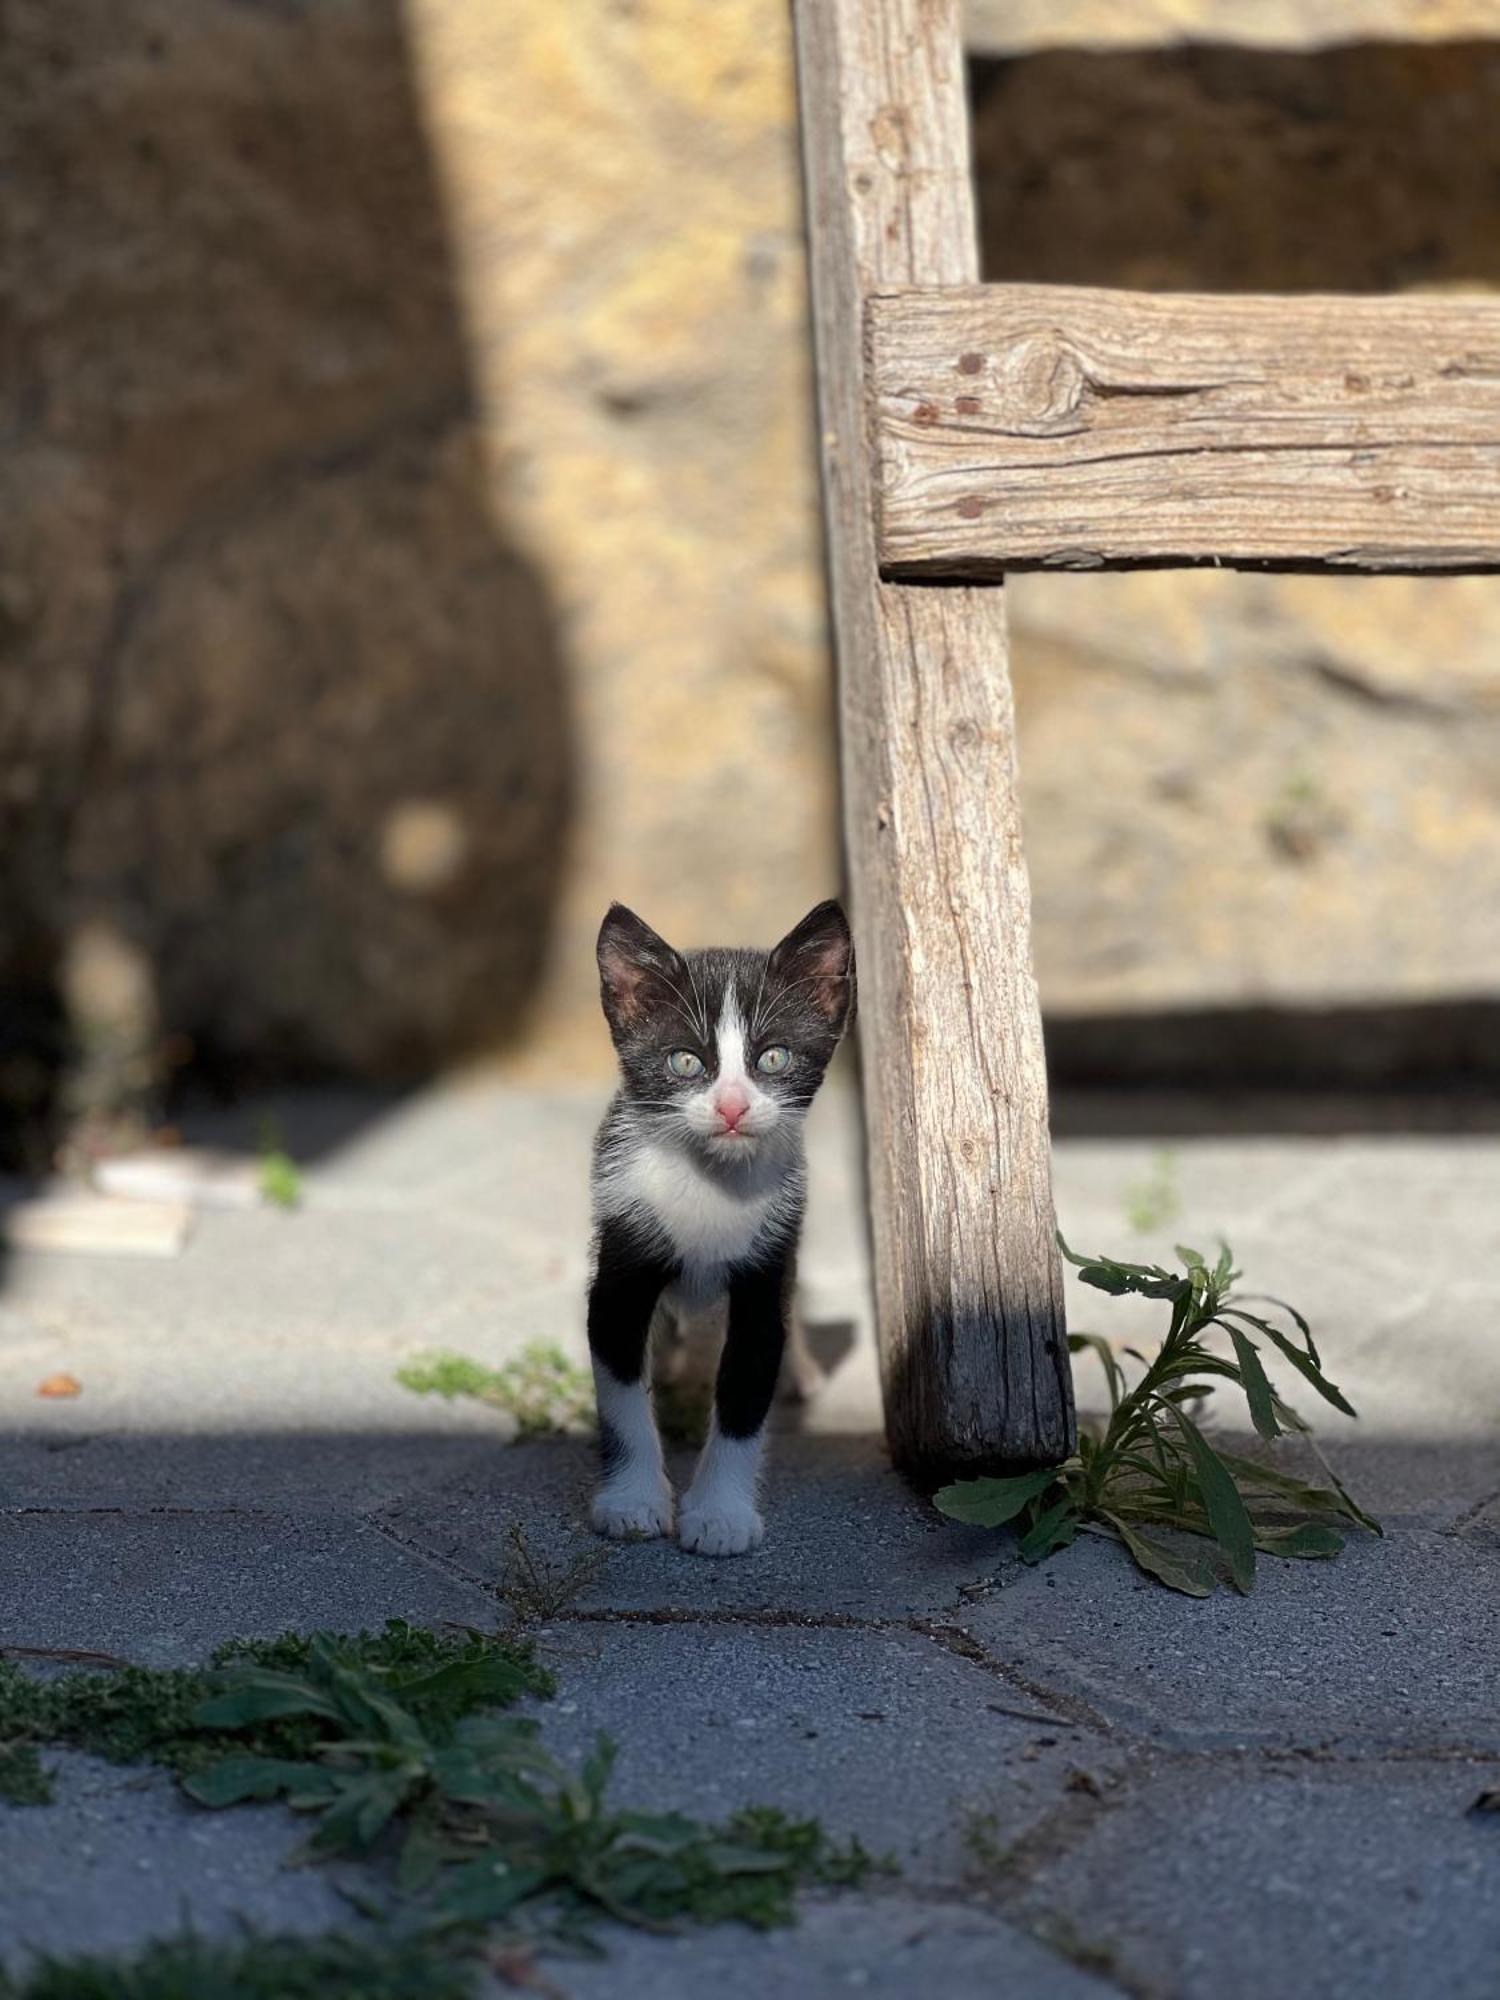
[678,1260,792,1556]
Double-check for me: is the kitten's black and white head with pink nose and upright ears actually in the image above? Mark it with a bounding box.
[598,902,854,1162]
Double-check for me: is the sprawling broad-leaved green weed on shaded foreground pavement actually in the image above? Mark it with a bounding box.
[184,1636,870,1936]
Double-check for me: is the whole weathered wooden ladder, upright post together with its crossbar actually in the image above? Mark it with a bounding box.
[794,0,1500,1476]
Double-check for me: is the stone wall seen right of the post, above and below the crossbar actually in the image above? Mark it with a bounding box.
[974,35,1500,1014]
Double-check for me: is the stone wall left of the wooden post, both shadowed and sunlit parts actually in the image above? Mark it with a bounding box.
[0,0,838,1128]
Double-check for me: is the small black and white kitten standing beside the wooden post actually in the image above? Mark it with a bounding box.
[588,902,854,1556]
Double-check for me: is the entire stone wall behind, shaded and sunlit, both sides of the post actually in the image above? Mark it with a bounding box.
[0,0,1500,1128]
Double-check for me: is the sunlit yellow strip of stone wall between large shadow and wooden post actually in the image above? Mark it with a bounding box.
[410,0,838,1064]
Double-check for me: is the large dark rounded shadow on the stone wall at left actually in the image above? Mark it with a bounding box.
[0,0,572,1168]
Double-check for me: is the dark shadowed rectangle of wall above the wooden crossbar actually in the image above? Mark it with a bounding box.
[972,42,1500,292]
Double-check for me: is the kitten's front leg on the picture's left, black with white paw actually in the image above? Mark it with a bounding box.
[588,1222,674,1538]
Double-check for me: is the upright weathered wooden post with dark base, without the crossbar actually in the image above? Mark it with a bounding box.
[794,0,1074,1478]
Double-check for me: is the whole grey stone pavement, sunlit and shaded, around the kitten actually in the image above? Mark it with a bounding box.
[0,1078,1500,2000]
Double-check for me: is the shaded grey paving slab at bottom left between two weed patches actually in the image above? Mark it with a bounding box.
[0,1750,350,1968]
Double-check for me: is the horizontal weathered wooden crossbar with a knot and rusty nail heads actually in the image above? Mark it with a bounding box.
[868,284,1500,576]
